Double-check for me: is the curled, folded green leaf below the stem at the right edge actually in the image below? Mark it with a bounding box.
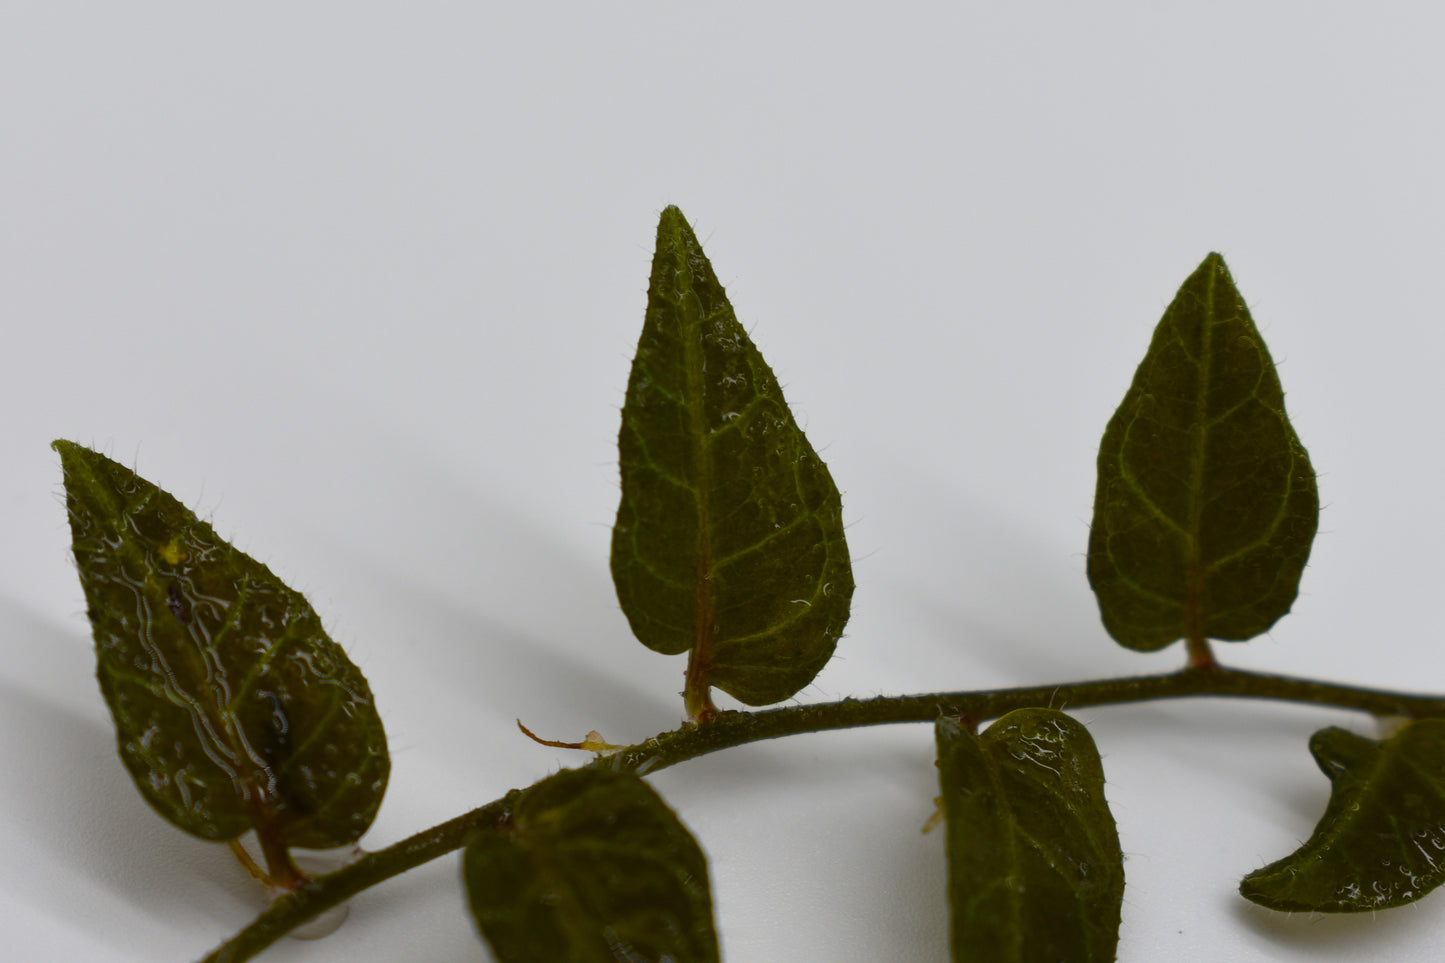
[1240,719,1445,912]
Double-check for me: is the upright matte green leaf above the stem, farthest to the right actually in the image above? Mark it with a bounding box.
[1088,254,1319,651]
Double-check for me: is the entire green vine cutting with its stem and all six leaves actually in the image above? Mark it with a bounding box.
[55,207,1445,963]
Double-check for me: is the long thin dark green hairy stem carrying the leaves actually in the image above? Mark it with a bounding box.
[202,661,1445,963]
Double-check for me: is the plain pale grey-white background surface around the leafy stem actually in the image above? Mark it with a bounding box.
[0,0,1445,963]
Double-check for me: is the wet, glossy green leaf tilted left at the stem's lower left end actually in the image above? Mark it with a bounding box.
[53,441,390,852]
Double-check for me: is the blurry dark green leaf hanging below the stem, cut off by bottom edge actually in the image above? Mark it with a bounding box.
[462,769,718,963]
